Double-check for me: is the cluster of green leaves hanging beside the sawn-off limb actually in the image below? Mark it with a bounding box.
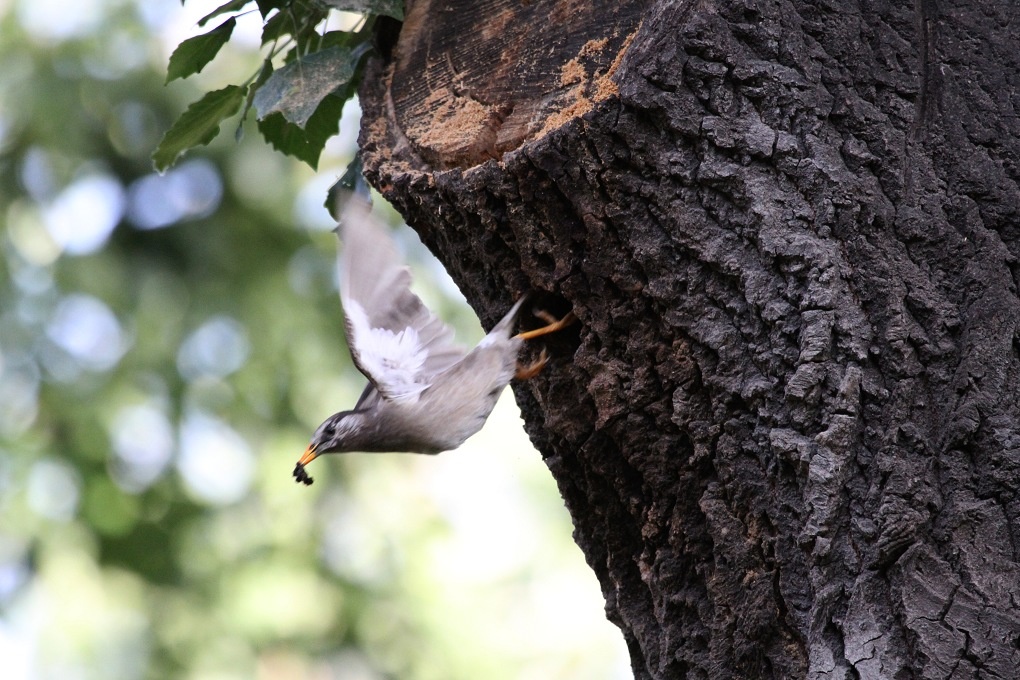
[152,0,404,172]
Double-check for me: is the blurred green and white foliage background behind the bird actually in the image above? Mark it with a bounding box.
[0,0,630,680]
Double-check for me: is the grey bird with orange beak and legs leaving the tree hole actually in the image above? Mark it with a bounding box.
[294,194,576,484]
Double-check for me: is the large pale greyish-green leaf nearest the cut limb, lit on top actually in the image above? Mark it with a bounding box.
[255,43,369,127]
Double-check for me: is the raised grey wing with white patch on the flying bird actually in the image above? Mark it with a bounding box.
[338,195,466,403]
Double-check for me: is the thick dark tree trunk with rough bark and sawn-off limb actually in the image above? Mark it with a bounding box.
[361,0,1020,679]
